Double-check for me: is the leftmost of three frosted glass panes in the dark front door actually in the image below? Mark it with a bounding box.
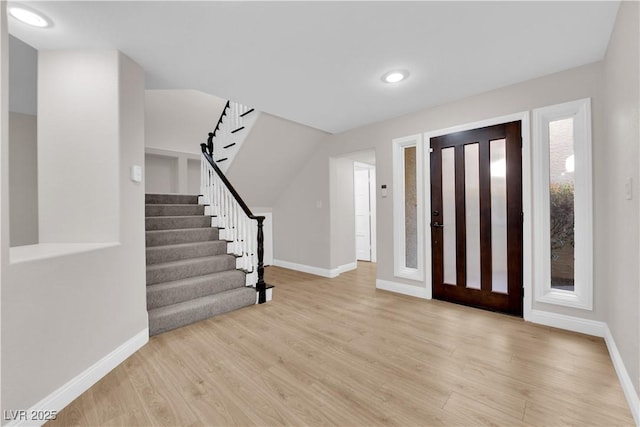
[442,148,456,285]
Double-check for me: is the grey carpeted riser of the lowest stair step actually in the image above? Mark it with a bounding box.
[149,288,255,335]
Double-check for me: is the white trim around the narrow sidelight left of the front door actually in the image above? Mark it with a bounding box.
[392,134,424,281]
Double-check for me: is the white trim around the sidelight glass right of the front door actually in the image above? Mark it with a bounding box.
[532,98,593,310]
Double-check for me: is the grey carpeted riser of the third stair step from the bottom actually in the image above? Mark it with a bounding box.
[147,256,236,285]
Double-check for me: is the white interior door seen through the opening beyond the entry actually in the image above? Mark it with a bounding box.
[354,166,372,261]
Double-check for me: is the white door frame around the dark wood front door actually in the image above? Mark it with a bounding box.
[420,111,533,320]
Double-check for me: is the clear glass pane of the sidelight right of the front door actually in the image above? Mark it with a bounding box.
[549,118,575,291]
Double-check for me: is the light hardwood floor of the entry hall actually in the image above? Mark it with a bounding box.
[49,263,633,426]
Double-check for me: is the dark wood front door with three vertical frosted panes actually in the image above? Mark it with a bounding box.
[430,121,523,316]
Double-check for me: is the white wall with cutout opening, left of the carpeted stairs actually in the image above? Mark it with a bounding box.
[0,50,148,418]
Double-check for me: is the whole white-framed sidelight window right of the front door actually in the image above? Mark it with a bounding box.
[533,99,593,310]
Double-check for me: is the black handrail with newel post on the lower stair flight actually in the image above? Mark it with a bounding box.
[200,145,267,304]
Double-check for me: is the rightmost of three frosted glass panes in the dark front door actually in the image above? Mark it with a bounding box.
[489,139,508,293]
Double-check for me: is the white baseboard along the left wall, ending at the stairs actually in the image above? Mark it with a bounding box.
[6,328,149,426]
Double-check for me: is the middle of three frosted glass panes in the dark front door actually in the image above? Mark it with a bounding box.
[464,143,480,289]
